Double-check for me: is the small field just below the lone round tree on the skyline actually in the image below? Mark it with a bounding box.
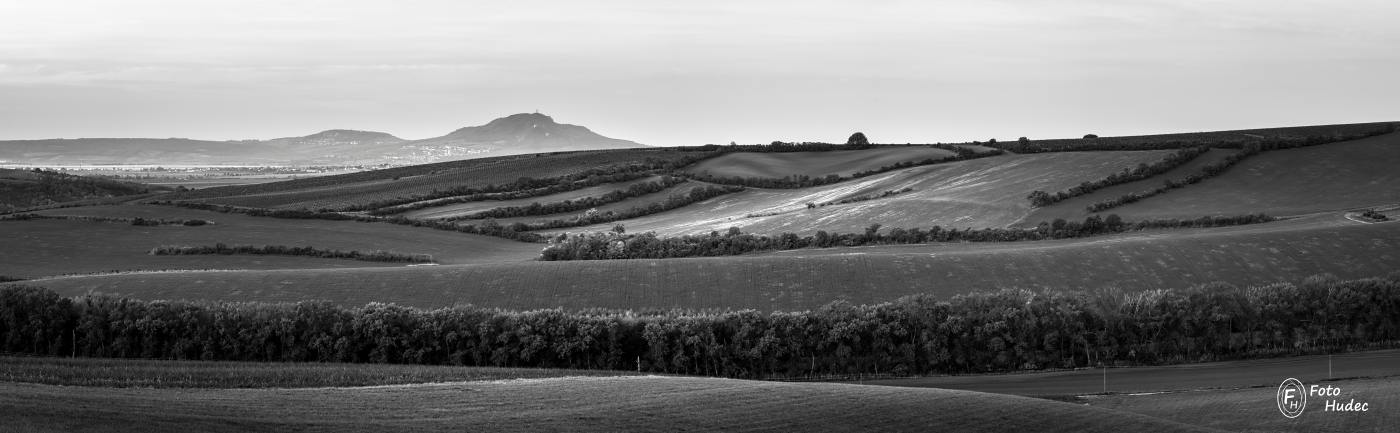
[674,146,953,178]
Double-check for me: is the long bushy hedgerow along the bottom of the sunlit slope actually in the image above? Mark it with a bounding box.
[539,214,1275,261]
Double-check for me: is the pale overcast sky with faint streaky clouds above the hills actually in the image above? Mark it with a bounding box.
[0,0,1400,146]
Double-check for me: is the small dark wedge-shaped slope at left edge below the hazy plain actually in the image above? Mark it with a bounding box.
[0,168,169,212]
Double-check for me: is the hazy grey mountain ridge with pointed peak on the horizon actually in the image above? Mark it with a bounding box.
[0,112,644,165]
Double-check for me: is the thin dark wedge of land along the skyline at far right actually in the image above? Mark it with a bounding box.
[986,122,1400,153]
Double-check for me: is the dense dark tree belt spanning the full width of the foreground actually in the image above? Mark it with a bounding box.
[0,275,1400,378]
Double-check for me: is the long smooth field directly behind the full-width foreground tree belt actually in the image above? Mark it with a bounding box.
[13,214,1400,311]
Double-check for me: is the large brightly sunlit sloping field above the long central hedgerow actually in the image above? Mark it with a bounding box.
[551,151,1169,235]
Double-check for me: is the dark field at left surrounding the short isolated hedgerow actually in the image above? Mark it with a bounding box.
[0,205,540,277]
